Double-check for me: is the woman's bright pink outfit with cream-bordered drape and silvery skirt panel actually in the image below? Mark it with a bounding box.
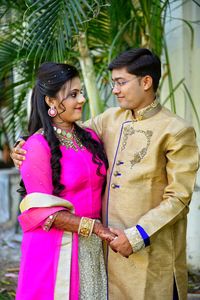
[16,131,107,300]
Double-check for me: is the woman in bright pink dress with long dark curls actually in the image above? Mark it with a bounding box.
[16,63,114,300]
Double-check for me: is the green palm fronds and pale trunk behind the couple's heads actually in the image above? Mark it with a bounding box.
[0,0,200,150]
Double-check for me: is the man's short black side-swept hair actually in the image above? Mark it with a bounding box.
[108,48,161,92]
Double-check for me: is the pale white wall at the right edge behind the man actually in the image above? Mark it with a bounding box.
[161,0,200,271]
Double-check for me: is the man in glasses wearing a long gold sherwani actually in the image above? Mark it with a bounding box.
[13,49,198,300]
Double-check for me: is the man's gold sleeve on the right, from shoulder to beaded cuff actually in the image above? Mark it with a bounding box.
[133,127,199,239]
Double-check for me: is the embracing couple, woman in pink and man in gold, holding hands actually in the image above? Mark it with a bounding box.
[12,48,198,300]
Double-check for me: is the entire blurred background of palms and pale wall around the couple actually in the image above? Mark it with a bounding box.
[0,0,200,300]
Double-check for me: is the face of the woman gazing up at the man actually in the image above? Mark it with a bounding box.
[52,77,85,127]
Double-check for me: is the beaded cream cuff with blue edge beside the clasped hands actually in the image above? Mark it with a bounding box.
[124,225,149,253]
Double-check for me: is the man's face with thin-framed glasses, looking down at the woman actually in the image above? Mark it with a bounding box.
[112,68,152,111]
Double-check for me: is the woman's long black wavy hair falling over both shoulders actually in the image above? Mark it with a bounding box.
[19,62,108,196]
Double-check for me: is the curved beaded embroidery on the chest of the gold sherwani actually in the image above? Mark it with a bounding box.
[121,125,153,168]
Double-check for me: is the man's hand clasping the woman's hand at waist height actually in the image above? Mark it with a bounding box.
[110,228,133,258]
